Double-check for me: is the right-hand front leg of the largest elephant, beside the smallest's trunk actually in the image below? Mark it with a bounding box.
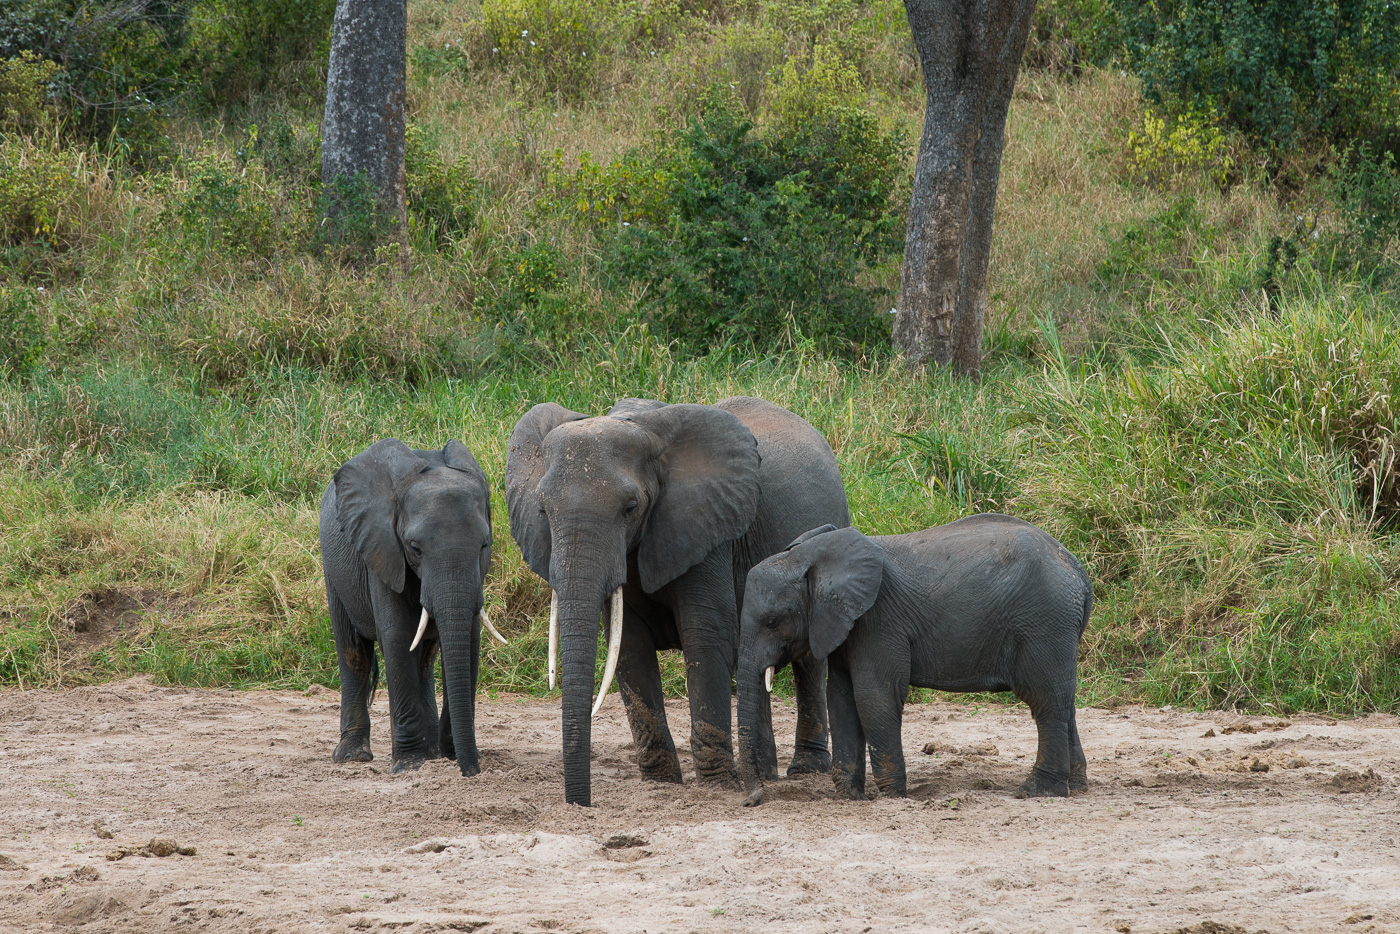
[672,543,739,788]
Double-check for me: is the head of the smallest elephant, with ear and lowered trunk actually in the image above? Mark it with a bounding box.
[735,525,885,790]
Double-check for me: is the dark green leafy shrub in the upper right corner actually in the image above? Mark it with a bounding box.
[1113,0,1400,150]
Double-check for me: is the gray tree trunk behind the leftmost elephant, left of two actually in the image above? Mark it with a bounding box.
[321,0,409,266]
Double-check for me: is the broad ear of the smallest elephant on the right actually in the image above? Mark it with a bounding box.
[792,528,885,660]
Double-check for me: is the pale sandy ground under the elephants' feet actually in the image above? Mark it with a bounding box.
[0,679,1400,934]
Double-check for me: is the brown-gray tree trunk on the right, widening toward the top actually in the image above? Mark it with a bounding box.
[895,0,1036,377]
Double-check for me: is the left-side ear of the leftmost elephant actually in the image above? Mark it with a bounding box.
[335,438,428,594]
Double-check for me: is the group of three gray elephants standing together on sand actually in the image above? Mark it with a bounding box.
[321,398,1093,805]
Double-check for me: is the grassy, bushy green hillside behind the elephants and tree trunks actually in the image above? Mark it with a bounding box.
[0,0,1400,713]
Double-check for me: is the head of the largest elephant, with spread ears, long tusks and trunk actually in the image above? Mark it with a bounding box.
[505,399,759,805]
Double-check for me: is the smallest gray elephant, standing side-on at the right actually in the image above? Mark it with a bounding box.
[738,514,1093,804]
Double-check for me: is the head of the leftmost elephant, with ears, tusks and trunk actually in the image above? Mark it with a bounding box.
[335,438,504,774]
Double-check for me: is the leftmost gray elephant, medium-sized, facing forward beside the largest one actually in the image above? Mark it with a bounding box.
[321,438,491,776]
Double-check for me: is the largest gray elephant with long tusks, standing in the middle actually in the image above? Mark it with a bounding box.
[505,398,850,805]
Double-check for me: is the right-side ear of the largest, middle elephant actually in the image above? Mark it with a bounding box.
[629,403,759,594]
